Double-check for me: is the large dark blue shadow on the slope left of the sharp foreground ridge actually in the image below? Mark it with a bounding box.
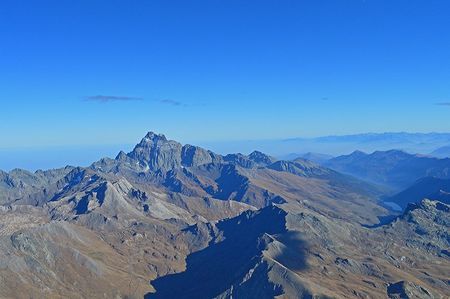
[145,206,305,299]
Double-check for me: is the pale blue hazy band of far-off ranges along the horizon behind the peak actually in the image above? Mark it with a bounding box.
[0,133,450,170]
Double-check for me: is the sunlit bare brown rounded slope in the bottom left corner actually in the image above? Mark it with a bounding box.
[0,205,151,298]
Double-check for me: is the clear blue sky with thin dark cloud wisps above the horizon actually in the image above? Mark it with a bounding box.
[0,0,450,169]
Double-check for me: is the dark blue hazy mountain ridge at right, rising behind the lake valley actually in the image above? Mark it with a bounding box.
[324,150,450,191]
